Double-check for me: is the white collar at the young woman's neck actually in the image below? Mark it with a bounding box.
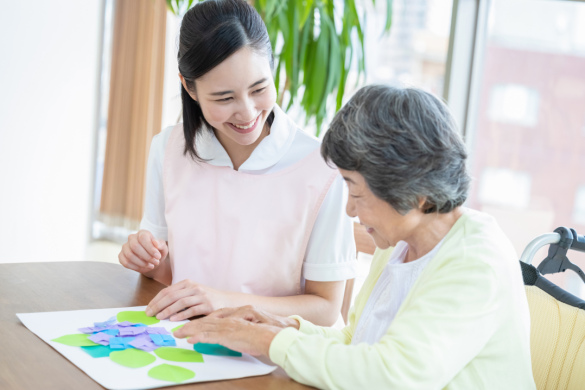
[197,104,297,171]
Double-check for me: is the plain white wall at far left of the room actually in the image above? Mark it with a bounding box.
[0,0,103,263]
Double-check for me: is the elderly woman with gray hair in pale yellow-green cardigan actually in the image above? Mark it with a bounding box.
[175,86,535,390]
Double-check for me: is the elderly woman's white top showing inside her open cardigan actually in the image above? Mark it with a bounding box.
[351,240,443,345]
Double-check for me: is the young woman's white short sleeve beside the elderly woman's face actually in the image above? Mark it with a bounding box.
[303,175,357,282]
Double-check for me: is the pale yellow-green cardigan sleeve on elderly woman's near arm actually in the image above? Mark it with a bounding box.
[270,251,502,390]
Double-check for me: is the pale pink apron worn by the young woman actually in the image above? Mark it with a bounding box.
[163,124,338,296]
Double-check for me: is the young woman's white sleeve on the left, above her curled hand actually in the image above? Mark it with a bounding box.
[140,127,173,241]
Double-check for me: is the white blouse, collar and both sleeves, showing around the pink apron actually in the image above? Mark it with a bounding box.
[140,105,357,282]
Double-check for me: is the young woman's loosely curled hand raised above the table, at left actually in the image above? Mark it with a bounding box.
[118,230,169,274]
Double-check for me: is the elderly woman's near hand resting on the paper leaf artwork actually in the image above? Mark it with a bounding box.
[174,306,298,356]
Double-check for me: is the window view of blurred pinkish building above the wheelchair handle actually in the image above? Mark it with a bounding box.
[466,0,585,298]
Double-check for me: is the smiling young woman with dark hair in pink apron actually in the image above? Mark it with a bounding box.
[119,0,355,325]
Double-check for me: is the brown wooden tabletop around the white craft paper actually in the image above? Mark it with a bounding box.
[0,262,309,390]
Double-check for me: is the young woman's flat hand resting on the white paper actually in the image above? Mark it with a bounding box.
[146,280,231,321]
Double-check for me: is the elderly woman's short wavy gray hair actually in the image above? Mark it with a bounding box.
[321,85,470,214]
